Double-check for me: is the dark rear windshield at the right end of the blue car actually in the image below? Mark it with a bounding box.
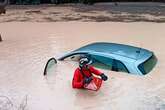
[138,55,157,75]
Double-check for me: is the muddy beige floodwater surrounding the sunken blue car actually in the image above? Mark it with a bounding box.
[0,22,165,110]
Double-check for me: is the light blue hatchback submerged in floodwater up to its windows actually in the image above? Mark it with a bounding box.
[58,42,157,75]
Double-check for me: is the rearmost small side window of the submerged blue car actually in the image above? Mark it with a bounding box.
[112,60,129,73]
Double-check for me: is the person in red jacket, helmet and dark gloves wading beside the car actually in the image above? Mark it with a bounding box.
[72,57,108,89]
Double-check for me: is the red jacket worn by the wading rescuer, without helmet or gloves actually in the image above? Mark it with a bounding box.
[72,66,102,88]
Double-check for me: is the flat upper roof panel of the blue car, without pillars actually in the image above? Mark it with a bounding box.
[75,42,149,60]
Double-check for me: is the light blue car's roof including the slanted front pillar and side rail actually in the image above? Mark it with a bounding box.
[59,42,152,64]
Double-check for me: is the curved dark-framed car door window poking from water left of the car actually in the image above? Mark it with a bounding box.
[44,58,57,76]
